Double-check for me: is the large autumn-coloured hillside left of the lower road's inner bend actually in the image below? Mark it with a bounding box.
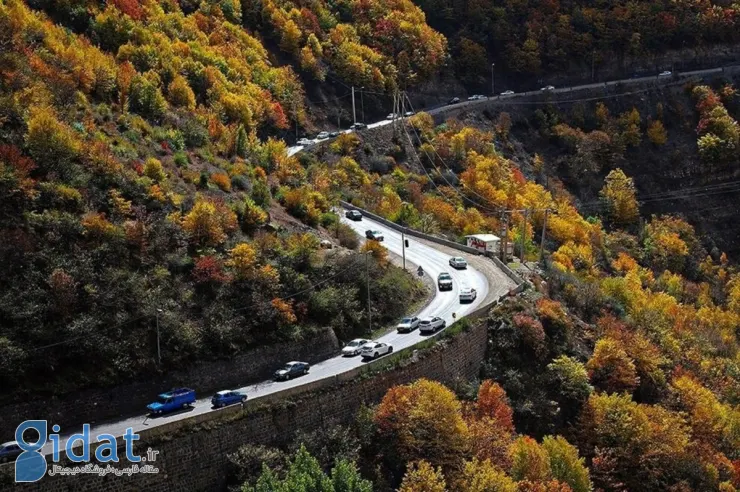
[0,1,428,395]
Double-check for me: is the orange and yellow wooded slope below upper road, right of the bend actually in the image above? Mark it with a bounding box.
[290,100,740,491]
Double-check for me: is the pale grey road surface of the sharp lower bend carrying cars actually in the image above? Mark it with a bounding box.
[42,210,489,454]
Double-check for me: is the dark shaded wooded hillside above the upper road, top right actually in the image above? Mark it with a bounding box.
[417,0,740,84]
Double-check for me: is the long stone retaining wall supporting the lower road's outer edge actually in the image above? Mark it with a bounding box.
[0,308,494,492]
